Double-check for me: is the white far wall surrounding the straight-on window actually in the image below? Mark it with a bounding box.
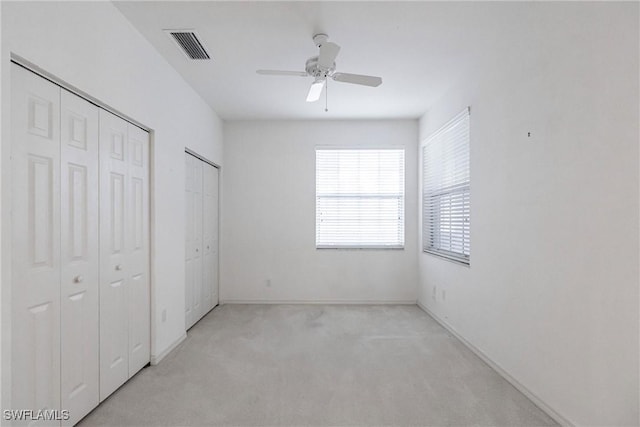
[220,120,418,302]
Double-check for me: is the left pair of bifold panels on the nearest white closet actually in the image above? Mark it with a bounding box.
[11,65,99,425]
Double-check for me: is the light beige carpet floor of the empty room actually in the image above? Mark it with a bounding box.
[80,305,556,427]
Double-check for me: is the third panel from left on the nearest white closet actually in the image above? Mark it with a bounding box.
[100,110,130,401]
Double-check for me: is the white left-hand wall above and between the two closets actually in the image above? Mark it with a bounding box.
[1,2,222,407]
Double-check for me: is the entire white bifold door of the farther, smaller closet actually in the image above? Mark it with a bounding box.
[185,153,218,329]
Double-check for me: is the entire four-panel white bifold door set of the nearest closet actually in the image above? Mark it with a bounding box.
[11,64,150,425]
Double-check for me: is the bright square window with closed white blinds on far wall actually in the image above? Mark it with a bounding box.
[316,148,404,248]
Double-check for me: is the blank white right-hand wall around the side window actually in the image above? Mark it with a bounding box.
[419,3,640,425]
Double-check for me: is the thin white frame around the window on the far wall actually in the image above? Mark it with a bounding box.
[314,144,407,250]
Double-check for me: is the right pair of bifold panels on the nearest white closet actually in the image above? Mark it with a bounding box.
[100,110,150,401]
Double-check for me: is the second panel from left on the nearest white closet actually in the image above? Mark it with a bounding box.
[60,90,99,425]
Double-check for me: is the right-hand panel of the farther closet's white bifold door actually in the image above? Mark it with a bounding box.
[203,163,218,311]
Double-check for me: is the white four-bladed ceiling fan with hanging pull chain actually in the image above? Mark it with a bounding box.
[256,34,382,102]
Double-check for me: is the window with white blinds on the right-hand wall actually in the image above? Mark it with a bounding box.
[422,108,470,264]
